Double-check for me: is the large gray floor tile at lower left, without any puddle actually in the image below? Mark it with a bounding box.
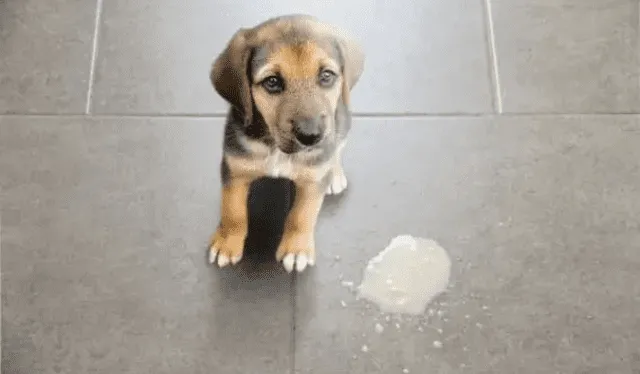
[0,117,293,374]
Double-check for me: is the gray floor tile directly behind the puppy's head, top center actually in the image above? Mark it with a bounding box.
[94,0,492,113]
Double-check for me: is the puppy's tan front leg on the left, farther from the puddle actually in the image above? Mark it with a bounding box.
[209,177,251,267]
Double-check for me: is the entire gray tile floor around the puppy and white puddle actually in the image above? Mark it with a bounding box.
[0,0,640,374]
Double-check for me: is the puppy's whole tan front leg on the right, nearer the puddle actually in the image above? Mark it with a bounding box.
[276,182,326,272]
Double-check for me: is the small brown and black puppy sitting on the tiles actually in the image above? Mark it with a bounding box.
[209,15,364,272]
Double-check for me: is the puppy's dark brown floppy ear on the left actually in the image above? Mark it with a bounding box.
[210,29,253,123]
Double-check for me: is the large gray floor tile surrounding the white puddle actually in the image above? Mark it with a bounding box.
[295,116,640,374]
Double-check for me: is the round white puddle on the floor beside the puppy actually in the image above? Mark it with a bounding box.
[358,235,451,315]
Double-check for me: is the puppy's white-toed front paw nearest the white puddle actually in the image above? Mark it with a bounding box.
[276,231,316,273]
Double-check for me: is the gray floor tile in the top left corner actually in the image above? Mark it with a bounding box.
[0,0,96,113]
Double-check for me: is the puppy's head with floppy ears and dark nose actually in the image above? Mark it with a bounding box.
[211,16,364,153]
